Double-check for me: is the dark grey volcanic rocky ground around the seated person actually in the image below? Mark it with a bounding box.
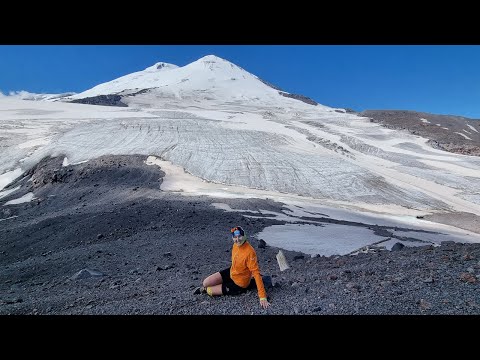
[0,156,480,315]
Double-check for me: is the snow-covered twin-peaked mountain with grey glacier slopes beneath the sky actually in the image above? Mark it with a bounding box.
[0,55,480,253]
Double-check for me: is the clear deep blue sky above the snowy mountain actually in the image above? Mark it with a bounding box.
[0,45,480,119]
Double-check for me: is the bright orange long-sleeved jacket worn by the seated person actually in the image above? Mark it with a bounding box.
[230,241,267,299]
